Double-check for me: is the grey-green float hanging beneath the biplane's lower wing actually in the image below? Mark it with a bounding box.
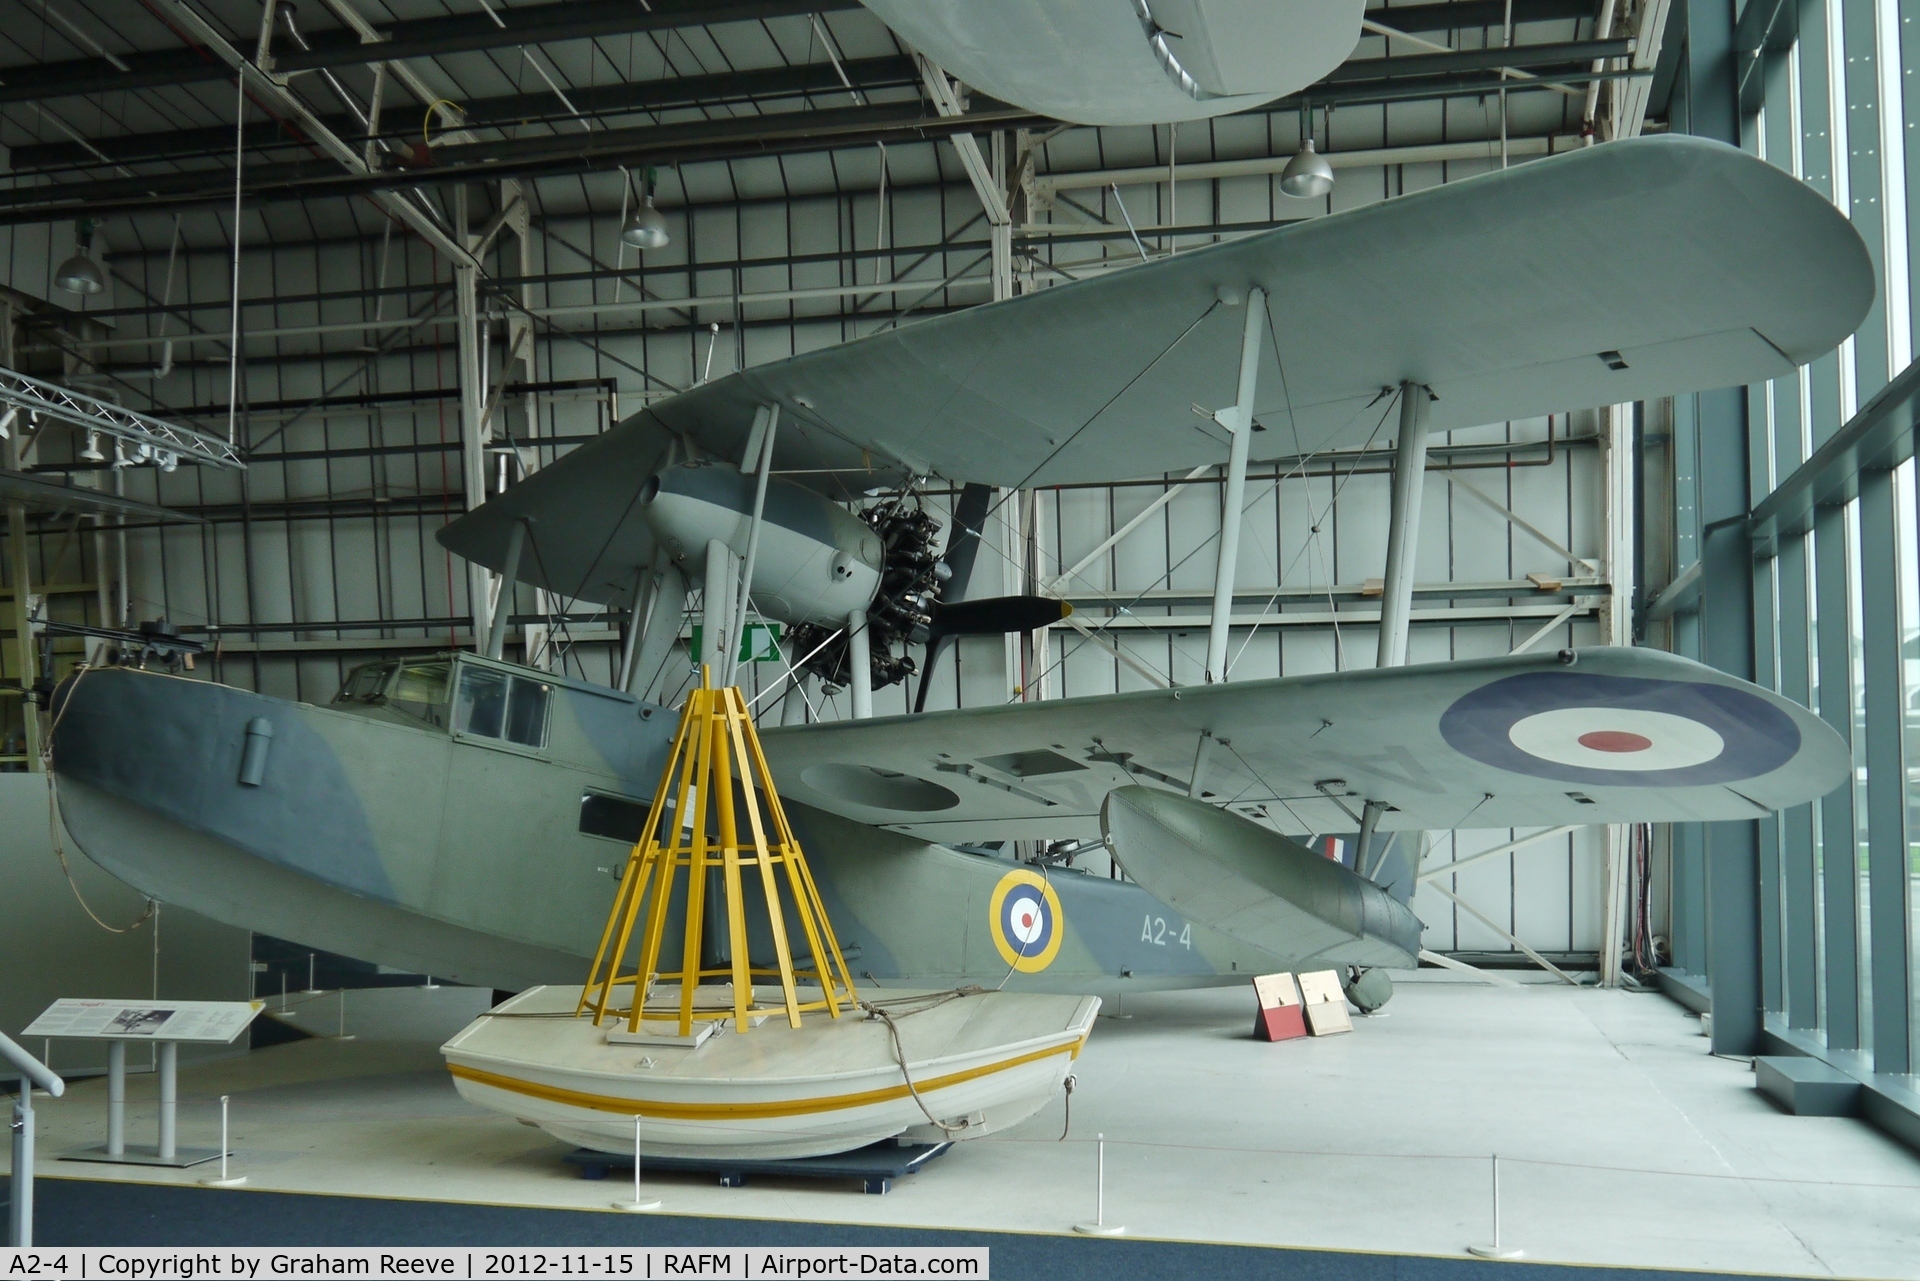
[1100,787,1421,968]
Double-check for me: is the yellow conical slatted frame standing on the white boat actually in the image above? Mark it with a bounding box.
[574,665,858,1037]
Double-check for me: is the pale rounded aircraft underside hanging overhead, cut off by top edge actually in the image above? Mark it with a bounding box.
[862,0,1365,125]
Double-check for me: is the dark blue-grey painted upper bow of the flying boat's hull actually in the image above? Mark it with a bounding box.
[52,668,392,899]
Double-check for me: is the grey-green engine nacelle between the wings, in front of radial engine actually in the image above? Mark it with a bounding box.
[639,463,885,628]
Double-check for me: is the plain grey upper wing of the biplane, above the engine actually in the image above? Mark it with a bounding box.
[442,136,1874,601]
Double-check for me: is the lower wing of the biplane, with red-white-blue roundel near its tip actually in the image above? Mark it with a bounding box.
[760,649,1849,841]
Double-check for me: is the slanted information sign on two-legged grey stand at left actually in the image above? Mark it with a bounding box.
[23,1001,265,1170]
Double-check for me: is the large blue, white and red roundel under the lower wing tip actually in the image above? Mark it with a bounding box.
[1440,672,1801,787]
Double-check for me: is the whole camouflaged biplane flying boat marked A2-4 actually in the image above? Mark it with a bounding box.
[52,136,1874,995]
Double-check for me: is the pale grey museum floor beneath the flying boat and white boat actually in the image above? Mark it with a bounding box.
[7,974,1920,1277]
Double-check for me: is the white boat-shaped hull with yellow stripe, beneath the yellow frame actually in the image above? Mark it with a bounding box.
[442,983,1100,1160]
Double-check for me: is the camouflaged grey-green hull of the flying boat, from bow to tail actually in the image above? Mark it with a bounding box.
[54,655,1351,995]
